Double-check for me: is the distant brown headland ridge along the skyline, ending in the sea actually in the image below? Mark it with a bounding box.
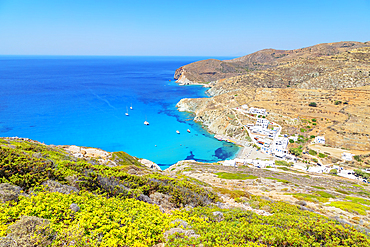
[174,42,370,84]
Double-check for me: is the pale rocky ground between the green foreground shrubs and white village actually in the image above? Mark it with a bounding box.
[165,161,370,230]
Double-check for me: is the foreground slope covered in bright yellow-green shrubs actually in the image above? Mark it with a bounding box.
[0,138,370,247]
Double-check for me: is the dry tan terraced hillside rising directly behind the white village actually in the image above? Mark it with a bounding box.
[178,42,370,151]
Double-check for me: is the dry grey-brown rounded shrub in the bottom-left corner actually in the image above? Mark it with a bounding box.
[6,216,55,247]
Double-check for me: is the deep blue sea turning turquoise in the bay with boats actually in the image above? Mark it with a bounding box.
[0,56,239,168]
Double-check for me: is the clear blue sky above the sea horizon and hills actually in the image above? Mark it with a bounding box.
[0,0,370,56]
